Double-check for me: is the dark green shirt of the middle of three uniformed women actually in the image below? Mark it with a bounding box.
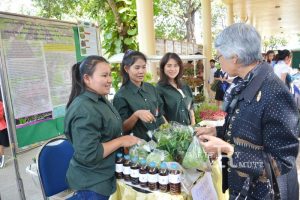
[113,81,164,141]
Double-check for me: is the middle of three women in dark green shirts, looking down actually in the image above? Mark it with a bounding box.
[113,50,165,141]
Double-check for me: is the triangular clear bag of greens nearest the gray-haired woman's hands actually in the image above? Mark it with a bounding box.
[182,136,211,171]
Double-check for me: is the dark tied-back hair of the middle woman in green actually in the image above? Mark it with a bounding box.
[121,50,147,86]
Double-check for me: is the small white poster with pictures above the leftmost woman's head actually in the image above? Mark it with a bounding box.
[78,22,99,56]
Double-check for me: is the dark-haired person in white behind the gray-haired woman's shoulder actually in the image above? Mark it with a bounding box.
[274,49,292,89]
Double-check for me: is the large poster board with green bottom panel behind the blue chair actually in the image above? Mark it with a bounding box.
[0,12,98,148]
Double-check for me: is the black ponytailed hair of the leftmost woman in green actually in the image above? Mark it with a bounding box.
[67,56,108,108]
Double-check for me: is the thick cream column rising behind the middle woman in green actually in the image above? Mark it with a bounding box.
[136,0,157,81]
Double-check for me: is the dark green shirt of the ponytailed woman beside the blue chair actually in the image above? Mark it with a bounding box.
[65,91,122,196]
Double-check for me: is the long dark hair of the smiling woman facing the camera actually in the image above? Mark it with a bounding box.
[158,52,183,88]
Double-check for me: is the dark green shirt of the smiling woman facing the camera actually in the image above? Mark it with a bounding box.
[156,83,194,125]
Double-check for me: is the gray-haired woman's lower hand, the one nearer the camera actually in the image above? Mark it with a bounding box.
[199,135,234,156]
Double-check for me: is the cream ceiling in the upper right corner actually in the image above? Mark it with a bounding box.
[223,0,300,37]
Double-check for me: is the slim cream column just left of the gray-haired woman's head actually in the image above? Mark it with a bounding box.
[201,0,212,99]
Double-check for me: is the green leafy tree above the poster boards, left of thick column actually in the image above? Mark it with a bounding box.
[34,0,138,57]
